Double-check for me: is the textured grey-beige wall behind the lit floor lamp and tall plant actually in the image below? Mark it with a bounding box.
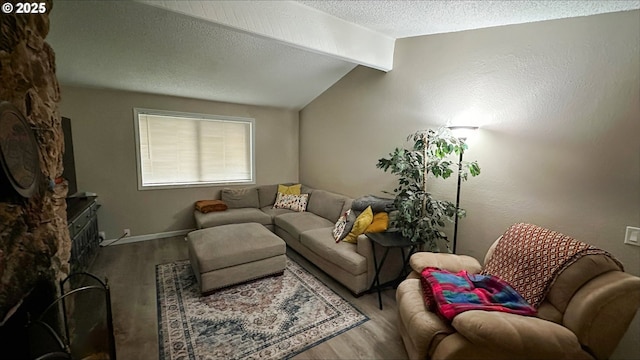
[300,11,640,359]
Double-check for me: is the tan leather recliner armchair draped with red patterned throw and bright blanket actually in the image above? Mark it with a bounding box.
[396,224,640,359]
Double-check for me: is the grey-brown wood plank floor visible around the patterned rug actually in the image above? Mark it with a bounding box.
[90,237,407,360]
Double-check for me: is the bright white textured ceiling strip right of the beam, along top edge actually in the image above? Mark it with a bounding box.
[300,0,640,38]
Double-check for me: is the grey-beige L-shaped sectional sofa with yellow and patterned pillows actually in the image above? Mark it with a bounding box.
[194,184,402,295]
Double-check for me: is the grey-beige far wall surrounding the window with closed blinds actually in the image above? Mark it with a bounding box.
[60,86,298,239]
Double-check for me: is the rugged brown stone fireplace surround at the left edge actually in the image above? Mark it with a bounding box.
[0,0,71,354]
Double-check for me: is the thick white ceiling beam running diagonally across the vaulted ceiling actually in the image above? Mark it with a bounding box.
[136,0,395,72]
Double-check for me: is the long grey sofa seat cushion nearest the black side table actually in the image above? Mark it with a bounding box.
[300,227,367,275]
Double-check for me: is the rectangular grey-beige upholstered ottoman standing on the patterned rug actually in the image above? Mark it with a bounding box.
[187,223,287,293]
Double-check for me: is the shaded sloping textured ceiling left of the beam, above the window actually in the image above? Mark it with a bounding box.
[48,1,355,108]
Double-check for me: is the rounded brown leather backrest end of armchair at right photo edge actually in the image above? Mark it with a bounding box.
[563,271,640,359]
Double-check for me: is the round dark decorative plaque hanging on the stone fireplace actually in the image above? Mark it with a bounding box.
[0,101,40,198]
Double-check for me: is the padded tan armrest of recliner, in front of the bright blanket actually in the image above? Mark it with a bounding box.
[452,310,590,359]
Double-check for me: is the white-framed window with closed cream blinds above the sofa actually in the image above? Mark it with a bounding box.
[134,109,255,190]
